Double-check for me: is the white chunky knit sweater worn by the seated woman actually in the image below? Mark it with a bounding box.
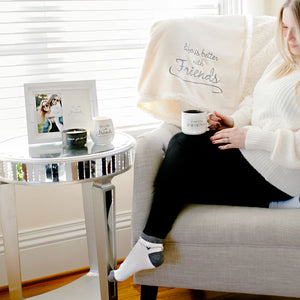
[232,56,300,196]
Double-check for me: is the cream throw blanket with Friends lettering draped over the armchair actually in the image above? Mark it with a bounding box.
[138,16,277,125]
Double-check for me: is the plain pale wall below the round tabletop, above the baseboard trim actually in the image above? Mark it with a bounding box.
[11,170,132,231]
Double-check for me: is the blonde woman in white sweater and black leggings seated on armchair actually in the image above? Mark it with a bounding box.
[109,0,300,281]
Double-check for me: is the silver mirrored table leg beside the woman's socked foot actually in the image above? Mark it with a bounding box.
[92,181,118,300]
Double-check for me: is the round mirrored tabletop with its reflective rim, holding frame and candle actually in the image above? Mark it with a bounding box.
[0,132,135,184]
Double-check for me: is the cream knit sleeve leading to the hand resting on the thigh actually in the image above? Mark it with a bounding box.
[245,126,300,169]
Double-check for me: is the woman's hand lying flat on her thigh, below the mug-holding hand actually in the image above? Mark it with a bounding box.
[210,128,248,150]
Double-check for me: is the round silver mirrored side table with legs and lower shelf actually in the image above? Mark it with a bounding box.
[0,132,135,300]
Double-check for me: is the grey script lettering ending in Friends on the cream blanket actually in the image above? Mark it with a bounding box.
[169,43,223,94]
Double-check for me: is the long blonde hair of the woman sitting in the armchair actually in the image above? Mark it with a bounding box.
[274,0,300,105]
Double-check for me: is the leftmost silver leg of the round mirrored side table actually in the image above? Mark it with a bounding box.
[0,182,23,300]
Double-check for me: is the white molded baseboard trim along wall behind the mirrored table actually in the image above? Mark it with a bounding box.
[0,211,131,286]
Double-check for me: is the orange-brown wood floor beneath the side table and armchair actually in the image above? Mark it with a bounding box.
[0,269,300,300]
